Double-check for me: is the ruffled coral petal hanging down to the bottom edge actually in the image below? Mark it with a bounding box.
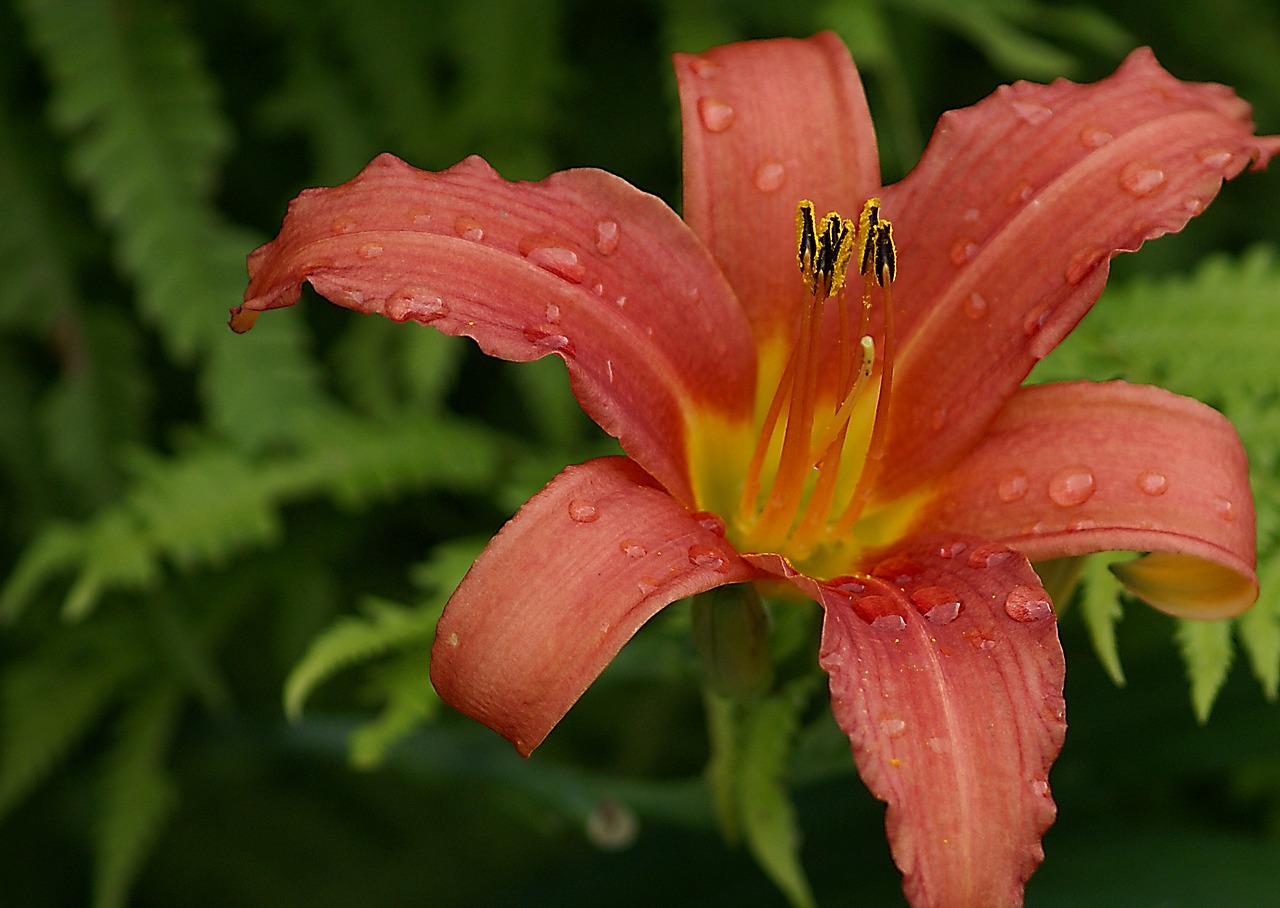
[752,539,1066,908]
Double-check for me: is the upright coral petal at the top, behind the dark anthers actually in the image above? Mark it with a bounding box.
[676,32,879,341]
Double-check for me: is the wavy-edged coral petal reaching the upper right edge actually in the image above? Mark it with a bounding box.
[878,49,1280,499]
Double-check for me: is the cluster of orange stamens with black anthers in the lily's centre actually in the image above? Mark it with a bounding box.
[735,199,896,561]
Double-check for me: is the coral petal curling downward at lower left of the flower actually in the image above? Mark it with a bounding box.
[431,457,755,757]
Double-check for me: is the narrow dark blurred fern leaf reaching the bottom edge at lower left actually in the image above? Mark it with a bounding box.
[92,683,182,908]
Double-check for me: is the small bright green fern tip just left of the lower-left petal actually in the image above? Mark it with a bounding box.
[284,599,440,720]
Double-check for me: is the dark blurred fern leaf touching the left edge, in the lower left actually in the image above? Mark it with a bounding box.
[0,616,147,818]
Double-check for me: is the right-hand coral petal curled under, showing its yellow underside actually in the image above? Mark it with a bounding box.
[918,382,1258,619]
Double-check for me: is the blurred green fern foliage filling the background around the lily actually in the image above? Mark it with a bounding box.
[0,0,1280,908]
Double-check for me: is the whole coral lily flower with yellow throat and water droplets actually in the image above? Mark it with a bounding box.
[230,33,1280,905]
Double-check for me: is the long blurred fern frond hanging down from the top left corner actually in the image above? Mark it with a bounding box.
[20,0,321,446]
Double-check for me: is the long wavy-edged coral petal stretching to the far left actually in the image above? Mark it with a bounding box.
[232,155,755,502]
